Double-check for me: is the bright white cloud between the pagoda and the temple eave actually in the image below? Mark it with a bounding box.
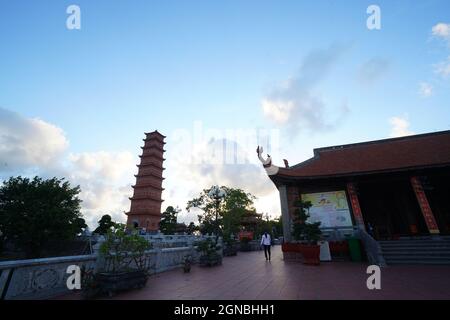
[163,139,280,222]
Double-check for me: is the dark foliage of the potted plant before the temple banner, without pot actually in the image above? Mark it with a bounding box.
[292,200,322,245]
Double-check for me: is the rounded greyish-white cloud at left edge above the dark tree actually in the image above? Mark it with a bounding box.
[0,108,69,173]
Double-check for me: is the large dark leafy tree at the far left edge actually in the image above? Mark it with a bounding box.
[0,176,87,258]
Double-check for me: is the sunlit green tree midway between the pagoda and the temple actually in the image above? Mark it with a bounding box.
[186,186,256,237]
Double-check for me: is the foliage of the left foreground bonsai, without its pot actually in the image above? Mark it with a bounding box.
[100,223,150,273]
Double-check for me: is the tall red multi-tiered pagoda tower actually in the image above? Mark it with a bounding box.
[127,130,166,231]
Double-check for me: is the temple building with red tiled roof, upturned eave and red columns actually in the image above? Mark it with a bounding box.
[257,131,450,241]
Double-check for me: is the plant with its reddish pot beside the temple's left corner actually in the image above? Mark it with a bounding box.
[282,200,322,265]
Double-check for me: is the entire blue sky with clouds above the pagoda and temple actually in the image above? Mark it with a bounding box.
[0,0,450,226]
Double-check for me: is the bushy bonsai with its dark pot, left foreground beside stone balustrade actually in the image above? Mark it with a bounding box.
[95,224,150,296]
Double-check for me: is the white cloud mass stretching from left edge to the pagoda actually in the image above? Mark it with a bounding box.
[0,108,137,227]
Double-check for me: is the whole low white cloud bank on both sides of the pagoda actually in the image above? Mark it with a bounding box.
[0,109,280,229]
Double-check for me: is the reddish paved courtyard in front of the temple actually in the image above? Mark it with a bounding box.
[58,246,450,300]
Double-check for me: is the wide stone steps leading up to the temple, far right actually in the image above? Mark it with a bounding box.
[379,236,450,265]
